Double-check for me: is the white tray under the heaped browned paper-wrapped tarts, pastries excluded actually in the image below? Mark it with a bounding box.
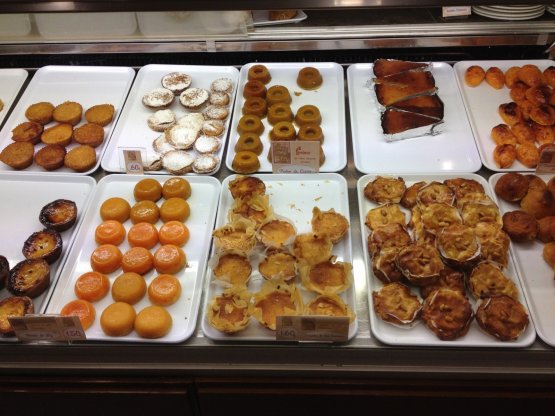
[357,173,536,348]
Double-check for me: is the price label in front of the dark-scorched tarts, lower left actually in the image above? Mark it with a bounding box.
[8,315,87,341]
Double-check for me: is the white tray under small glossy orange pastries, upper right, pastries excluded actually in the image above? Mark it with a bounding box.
[454,59,554,172]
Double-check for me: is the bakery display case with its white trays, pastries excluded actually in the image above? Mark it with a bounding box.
[0,0,555,415]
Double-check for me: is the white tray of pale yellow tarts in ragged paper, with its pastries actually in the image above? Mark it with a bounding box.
[202,173,358,341]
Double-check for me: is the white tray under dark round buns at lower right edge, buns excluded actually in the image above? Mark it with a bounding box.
[489,173,555,347]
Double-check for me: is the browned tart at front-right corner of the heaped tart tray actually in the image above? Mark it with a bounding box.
[476,295,529,341]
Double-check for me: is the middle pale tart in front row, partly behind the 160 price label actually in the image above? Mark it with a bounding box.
[250,280,304,331]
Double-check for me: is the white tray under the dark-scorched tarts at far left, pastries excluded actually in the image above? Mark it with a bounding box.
[0,173,96,342]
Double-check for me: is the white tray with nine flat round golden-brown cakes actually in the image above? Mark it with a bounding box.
[0,65,135,175]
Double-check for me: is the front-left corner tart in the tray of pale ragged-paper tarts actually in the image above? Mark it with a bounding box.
[207,285,250,334]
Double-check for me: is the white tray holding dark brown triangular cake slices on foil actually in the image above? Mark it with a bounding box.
[347,59,481,173]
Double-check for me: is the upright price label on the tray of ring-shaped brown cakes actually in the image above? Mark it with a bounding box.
[270,140,320,173]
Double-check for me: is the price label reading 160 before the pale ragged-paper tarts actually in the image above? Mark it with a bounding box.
[276,316,349,342]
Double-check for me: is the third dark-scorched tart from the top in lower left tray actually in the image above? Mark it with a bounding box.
[7,259,50,298]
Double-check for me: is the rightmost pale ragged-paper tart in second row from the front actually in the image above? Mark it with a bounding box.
[301,258,353,295]
